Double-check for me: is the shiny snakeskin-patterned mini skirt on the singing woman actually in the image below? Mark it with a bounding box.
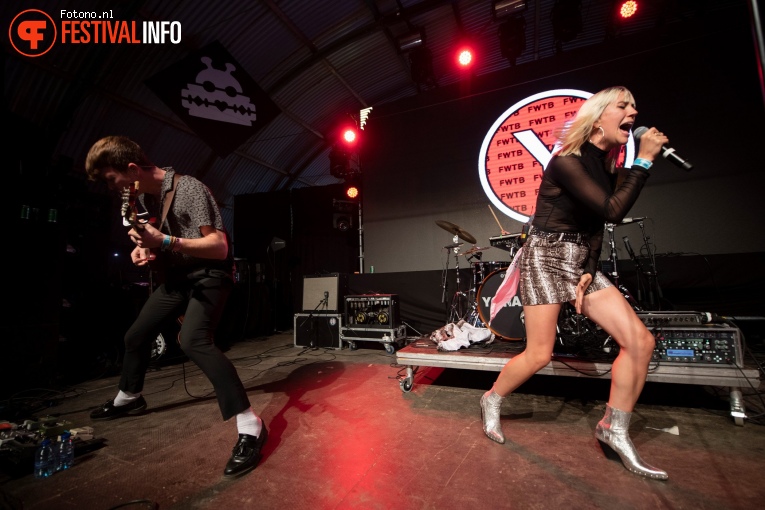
[519,233,613,305]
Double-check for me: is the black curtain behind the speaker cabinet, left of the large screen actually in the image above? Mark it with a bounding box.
[234,184,359,335]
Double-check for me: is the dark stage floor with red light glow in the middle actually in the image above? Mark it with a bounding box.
[0,332,765,510]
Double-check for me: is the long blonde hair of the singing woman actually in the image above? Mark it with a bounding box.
[557,86,635,172]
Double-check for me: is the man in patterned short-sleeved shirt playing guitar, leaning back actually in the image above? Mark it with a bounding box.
[85,136,268,477]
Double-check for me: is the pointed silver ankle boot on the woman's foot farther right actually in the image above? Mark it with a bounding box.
[595,404,669,480]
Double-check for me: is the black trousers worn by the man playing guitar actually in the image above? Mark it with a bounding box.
[119,277,250,420]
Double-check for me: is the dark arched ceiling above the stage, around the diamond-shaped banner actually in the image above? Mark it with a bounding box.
[2,0,746,233]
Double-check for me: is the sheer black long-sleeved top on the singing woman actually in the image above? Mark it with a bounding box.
[532,142,649,276]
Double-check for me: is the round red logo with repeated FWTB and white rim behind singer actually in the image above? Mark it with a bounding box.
[478,89,634,222]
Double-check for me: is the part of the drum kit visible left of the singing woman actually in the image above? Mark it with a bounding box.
[436,220,525,340]
